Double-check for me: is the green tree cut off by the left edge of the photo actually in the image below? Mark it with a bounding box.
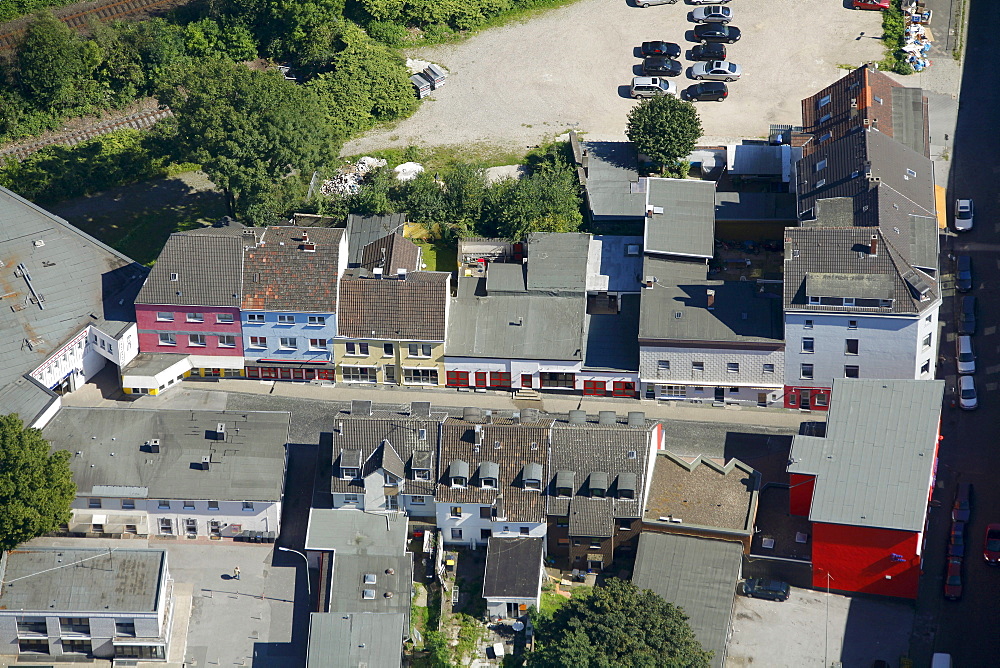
[0,413,76,551]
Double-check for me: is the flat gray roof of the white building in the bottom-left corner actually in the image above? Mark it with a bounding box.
[0,546,167,616]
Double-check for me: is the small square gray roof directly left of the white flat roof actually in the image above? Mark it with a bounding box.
[528,232,590,294]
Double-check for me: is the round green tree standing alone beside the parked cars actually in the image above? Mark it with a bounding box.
[626,95,702,176]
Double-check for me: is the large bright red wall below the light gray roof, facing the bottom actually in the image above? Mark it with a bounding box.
[812,523,920,598]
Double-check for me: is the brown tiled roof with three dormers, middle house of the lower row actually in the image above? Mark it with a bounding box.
[434,418,552,522]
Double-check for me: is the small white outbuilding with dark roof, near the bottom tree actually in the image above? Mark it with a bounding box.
[483,536,545,619]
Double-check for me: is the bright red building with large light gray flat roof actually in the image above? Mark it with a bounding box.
[787,379,944,599]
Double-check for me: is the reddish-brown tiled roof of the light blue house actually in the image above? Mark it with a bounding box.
[242,227,346,313]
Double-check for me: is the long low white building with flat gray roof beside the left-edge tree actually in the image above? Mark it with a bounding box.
[43,407,289,539]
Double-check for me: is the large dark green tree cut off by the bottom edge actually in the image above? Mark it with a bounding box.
[527,578,712,668]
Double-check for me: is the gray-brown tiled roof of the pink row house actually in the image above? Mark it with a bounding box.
[135,233,244,308]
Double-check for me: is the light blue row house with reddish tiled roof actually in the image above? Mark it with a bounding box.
[240,227,347,380]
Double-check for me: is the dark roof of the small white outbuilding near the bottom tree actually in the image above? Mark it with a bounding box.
[483,536,545,598]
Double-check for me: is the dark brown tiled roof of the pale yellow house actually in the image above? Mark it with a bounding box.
[337,269,451,341]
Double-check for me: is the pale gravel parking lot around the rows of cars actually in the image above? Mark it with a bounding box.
[343,0,882,155]
